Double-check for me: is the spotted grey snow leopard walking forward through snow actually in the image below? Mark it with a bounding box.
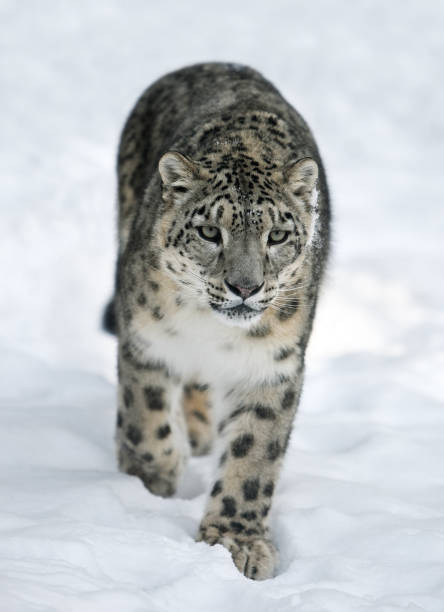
[105,63,330,580]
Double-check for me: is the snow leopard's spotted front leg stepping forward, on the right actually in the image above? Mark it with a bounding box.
[197,374,302,580]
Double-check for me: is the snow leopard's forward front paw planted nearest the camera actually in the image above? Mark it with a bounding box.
[197,525,278,580]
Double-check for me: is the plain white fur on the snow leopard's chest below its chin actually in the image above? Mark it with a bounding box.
[130,306,294,389]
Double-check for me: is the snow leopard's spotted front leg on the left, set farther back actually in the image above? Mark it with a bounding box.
[116,342,190,497]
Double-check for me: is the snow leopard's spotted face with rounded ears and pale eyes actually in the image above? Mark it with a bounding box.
[159,153,317,325]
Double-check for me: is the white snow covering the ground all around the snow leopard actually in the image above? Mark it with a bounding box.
[0,0,444,612]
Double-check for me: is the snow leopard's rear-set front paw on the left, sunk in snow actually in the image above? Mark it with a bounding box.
[118,443,181,497]
